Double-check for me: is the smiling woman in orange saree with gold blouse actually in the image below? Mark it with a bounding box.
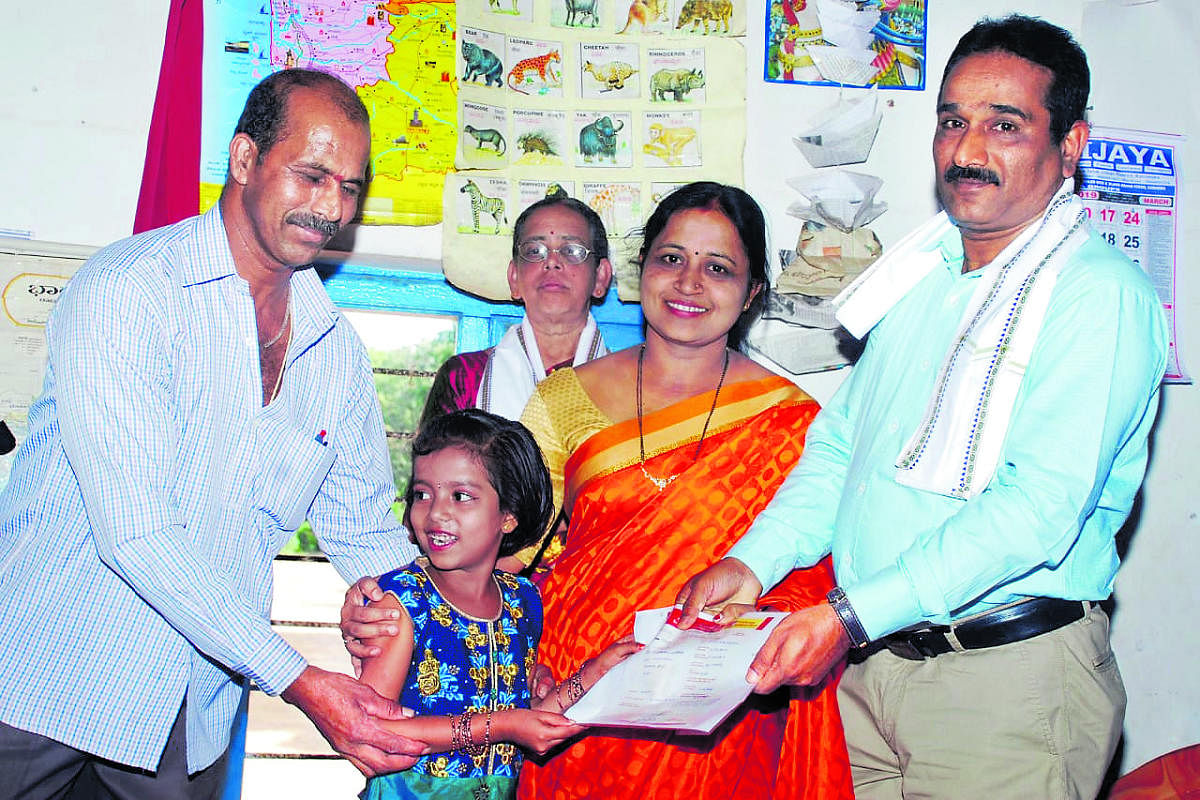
[517,184,852,800]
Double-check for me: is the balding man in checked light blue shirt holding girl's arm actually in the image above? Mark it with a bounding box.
[0,70,425,799]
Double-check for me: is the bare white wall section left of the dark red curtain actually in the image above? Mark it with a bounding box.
[0,0,168,245]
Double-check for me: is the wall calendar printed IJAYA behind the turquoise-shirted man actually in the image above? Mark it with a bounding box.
[1079,126,1192,384]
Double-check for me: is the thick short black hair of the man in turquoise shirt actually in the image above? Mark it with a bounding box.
[938,14,1092,142]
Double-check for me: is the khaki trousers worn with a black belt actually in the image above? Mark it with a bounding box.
[838,607,1126,800]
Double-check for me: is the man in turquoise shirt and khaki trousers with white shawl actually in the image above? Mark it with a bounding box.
[680,16,1168,798]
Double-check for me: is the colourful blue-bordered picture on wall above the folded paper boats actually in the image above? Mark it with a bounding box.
[763,0,928,89]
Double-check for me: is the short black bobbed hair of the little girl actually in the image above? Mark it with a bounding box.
[404,408,554,557]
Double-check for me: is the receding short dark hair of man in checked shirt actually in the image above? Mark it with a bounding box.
[234,67,371,161]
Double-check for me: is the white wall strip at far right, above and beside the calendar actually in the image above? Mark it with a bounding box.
[1081,0,1200,768]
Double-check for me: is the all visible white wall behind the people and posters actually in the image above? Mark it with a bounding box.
[0,0,1200,770]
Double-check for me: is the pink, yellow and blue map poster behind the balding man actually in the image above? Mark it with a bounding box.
[200,0,457,225]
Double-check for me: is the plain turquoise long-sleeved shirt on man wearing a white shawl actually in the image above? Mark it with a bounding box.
[728,224,1168,639]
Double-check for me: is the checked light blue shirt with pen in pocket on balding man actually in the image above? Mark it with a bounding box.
[0,209,416,771]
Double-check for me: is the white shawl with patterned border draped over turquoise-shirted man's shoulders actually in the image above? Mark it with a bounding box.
[834,181,1088,499]
